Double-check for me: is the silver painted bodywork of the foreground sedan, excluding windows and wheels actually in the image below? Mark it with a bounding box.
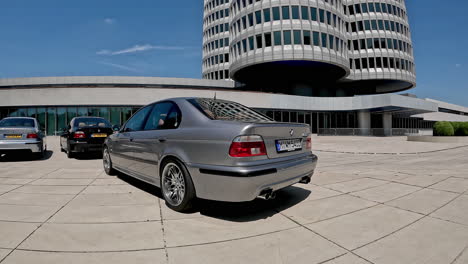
[105,98,317,202]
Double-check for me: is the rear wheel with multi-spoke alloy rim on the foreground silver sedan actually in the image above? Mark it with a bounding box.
[160,159,196,212]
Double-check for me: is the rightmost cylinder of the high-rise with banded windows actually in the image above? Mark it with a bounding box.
[344,0,416,94]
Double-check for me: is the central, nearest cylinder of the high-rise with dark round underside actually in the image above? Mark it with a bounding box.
[230,0,350,89]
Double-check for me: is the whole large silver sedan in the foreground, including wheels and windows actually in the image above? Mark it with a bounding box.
[103,98,317,211]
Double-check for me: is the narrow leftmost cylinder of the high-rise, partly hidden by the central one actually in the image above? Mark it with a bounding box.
[202,0,230,80]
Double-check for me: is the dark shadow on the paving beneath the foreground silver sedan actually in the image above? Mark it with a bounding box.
[117,173,311,222]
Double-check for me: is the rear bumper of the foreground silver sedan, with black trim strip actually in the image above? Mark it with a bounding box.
[188,154,318,202]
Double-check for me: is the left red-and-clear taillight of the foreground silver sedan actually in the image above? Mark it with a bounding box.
[229,136,266,158]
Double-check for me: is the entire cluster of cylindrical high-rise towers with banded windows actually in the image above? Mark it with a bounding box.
[203,0,416,97]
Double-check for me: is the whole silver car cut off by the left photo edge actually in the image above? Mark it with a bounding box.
[0,117,47,158]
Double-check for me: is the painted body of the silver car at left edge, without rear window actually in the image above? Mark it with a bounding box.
[0,117,47,153]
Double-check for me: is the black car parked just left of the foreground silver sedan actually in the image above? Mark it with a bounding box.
[60,117,114,158]
